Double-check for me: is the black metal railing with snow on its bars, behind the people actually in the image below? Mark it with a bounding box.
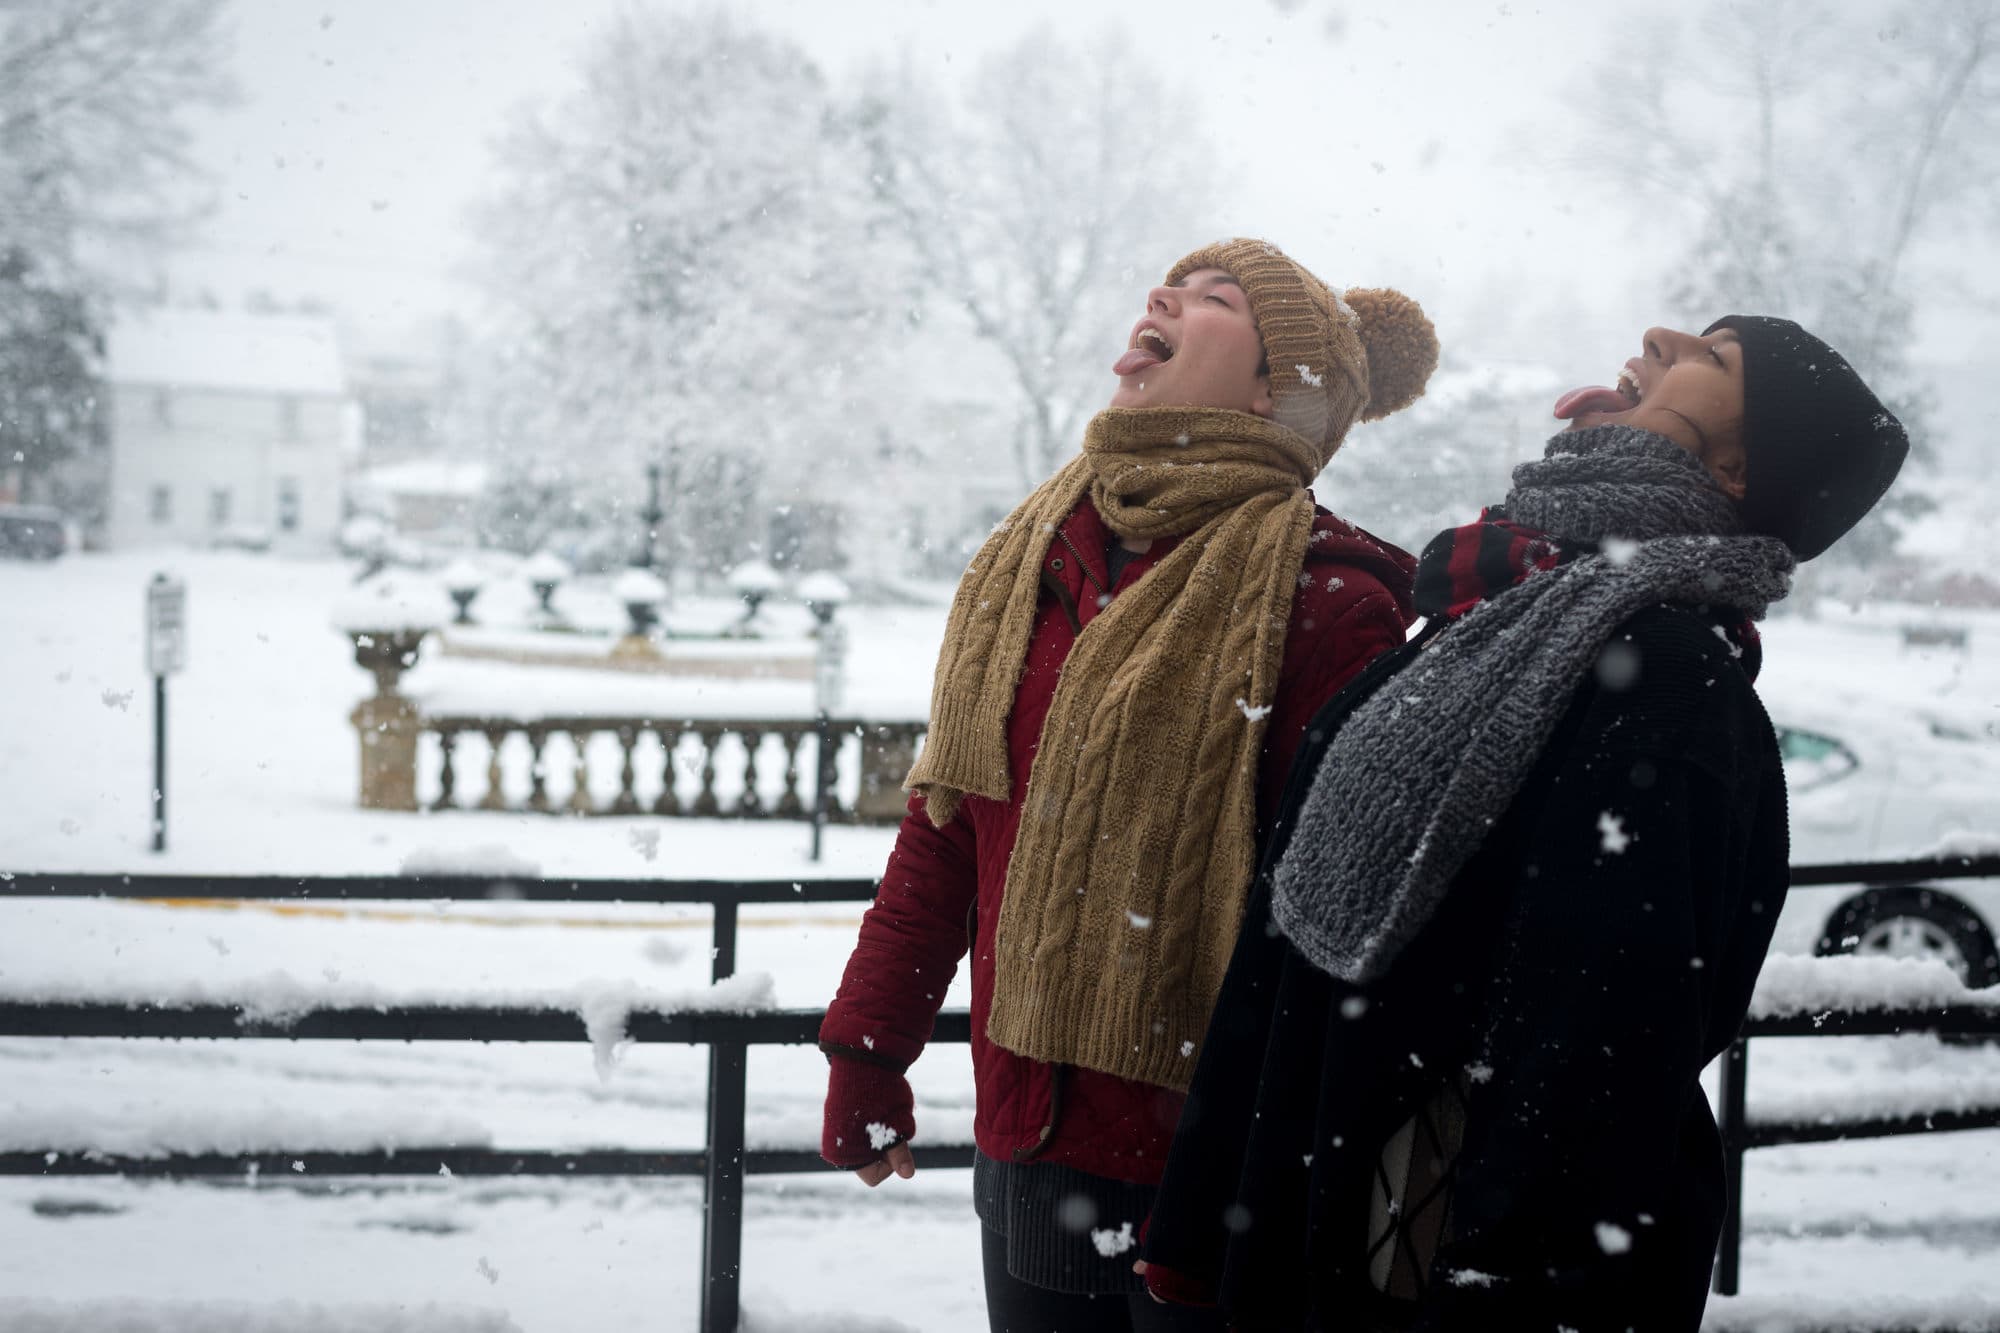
[0,857,2000,1333]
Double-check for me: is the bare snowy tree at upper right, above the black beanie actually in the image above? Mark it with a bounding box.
[1580,0,2000,562]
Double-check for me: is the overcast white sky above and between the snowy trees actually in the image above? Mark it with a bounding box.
[152,0,2000,452]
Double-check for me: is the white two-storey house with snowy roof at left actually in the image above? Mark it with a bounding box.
[104,308,360,548]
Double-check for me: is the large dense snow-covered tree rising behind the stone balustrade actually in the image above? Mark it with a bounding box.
[468,8,904,570]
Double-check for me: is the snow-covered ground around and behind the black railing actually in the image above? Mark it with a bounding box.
[0,554,2000,1333]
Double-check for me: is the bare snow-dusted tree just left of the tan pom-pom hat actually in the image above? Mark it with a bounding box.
[866,30,1214,486]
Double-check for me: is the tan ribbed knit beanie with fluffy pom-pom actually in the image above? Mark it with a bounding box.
[1166,238,1438,466]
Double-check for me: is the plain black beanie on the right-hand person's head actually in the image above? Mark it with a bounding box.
[1702,314,1910,560]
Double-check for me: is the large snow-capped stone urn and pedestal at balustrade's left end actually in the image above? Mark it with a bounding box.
[334,578,450,811]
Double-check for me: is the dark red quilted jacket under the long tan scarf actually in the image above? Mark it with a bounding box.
[820,496,1416,1185]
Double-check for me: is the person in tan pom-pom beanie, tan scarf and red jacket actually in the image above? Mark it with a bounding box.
[820,240,1438,1333]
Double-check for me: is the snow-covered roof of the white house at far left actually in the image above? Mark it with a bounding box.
[104,306,348,398]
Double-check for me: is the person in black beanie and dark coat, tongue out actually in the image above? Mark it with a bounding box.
[1140,316,1908,1333]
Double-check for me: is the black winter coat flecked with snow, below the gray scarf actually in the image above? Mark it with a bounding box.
[1146,606,1788,1333]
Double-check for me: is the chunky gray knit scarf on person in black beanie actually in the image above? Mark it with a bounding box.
[1272,426,1792,983]
